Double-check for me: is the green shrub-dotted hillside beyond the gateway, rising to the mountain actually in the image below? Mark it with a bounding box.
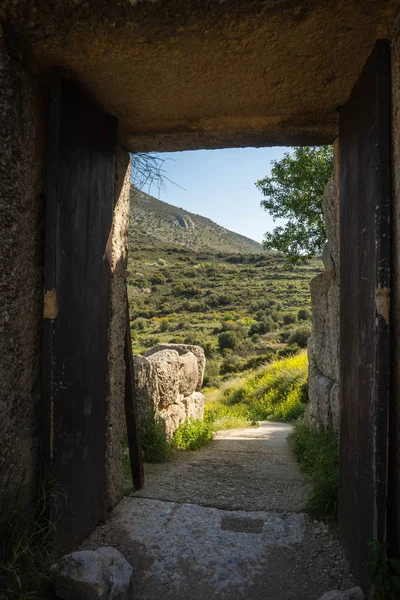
[128,185,322,385]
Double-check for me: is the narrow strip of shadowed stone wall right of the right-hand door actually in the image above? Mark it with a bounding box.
[388,22,400,550]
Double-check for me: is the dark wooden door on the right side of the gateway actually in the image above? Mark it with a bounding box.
[339,40,390,583]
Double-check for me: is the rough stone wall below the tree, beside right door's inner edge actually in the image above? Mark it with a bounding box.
[306,162,340,429]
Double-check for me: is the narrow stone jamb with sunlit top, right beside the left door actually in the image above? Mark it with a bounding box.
[107,148,130,508]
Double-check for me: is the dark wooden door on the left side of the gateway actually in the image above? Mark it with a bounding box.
[42,72,117,551]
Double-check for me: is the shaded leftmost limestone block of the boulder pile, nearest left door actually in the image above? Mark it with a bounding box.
[133,354,160,419]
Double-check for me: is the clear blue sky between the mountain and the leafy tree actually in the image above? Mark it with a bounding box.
[139,147,289,242]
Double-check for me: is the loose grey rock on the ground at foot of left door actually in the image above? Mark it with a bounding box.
[51,547,132,600]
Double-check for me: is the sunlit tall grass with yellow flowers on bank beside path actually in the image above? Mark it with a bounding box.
[205,352,307,429]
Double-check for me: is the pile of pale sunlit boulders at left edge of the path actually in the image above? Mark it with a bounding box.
[133,344,205,440]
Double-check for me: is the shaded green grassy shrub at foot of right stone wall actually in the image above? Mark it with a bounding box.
[290,421,339,524]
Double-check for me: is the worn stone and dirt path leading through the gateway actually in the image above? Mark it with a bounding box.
[85,423,354,600]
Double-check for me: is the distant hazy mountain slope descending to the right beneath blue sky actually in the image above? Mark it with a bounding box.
[129,186,262,254]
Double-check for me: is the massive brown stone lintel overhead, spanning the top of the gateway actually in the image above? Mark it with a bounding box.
[0,0,398,152]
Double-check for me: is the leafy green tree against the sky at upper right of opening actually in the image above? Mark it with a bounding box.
[256,146,334,264]
